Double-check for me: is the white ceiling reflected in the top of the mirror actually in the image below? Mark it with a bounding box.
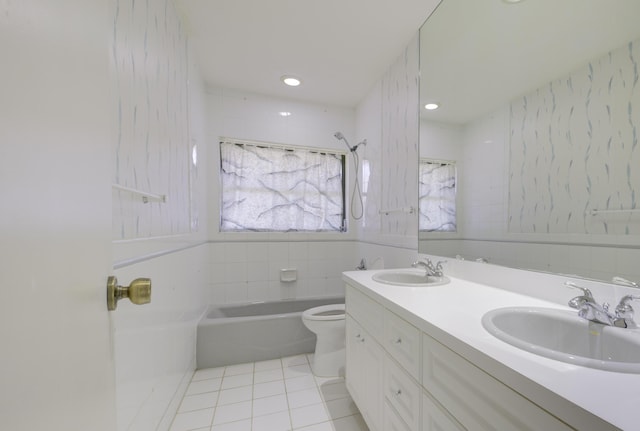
[420,0,640,124]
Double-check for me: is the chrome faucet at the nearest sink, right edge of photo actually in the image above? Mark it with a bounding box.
[564,281,640,329]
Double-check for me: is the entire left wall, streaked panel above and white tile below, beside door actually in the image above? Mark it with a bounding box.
[108,0,209,431]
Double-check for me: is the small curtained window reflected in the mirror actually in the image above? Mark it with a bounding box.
[418,159,456,232]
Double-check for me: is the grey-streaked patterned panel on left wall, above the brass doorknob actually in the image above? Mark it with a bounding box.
[110,0,191,239]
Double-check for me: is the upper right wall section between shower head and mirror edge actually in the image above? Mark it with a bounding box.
[356,37,419,255]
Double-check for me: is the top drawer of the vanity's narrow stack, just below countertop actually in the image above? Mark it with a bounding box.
[383,310,422,381]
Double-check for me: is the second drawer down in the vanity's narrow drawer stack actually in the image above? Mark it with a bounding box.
[384,355,422,430]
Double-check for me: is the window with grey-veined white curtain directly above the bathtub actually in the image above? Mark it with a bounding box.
[220,140,346,232]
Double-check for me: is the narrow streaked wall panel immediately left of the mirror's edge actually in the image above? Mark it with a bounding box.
[381,37,420,236]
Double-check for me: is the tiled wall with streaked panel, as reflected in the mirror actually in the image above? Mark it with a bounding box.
[420,38,640,280]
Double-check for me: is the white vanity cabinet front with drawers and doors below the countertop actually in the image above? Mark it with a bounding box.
[346,284,573,431]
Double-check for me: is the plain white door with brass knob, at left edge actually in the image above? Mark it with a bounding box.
[0,0,115,431]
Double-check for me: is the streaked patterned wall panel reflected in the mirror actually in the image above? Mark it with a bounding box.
[508,41,640,235]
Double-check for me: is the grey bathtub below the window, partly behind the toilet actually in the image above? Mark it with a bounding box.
[196,297,344,369]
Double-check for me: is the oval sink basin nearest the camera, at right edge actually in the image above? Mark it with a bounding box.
[482,307,640,373]
